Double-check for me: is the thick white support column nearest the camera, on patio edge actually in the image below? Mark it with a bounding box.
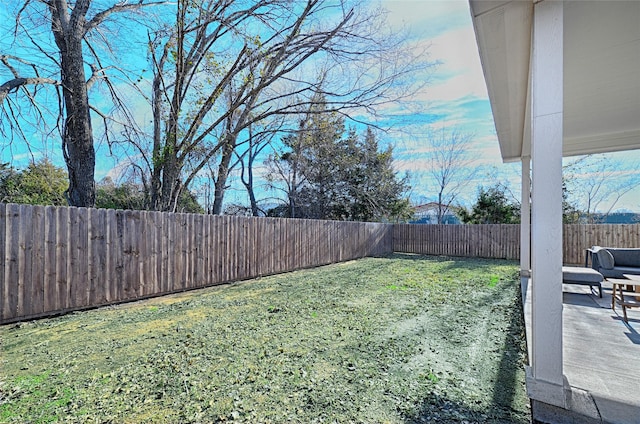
[528,0,565,407]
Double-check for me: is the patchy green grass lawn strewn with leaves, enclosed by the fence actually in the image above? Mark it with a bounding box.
[0,254,530,423]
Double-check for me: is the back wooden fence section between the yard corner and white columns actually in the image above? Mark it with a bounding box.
[393,224,520,259]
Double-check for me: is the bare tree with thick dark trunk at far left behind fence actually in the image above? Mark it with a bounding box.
[0,0,165,207]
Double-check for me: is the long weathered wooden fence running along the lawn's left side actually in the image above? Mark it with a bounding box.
[0,204,392,323]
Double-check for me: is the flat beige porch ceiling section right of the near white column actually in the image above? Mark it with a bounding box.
[563,1,640,156]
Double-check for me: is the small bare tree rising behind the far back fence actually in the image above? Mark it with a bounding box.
[427,128,477,224]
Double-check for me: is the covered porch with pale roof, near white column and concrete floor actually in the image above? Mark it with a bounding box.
[469,0,640,423]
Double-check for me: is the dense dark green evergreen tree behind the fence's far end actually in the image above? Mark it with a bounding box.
[268,98,410,221]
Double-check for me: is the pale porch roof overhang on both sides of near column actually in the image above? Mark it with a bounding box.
[469,0,640,162]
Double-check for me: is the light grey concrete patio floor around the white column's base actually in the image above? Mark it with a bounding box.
[522,278,640,424]
